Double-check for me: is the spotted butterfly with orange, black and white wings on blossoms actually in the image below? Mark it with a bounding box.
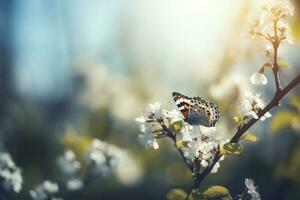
[172,92,220,127]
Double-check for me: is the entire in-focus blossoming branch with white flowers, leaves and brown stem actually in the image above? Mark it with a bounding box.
[135,0,300,199]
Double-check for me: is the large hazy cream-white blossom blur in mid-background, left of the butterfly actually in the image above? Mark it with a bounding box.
[74,61,141,120]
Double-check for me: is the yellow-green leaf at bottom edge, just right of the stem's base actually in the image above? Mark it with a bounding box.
[189,185,232,200]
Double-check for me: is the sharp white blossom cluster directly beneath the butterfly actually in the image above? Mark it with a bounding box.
[135,103,228,173]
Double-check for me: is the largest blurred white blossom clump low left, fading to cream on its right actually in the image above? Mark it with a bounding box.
[88,139,142,185]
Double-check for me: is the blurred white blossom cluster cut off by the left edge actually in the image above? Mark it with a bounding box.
[0,152,23,193]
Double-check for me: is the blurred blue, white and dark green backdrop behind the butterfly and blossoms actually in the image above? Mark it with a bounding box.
[0,0,300,200]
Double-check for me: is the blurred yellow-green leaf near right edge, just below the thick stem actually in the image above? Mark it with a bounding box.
[271,111,298,133]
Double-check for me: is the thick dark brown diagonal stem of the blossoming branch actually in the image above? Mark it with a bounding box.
[194,74,300,188]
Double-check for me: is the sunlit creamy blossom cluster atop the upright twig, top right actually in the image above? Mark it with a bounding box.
[250,0,295,43]
